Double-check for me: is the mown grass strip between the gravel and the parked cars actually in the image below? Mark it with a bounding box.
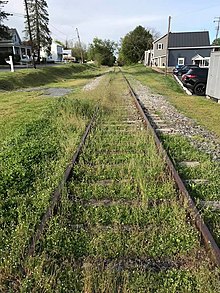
[123,65,220,137]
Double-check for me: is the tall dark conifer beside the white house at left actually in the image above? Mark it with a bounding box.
[24,0,52,62]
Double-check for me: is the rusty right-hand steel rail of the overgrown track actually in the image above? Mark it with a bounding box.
[121,71,220,266]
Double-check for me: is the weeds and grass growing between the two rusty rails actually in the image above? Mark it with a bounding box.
[10,69,219,293]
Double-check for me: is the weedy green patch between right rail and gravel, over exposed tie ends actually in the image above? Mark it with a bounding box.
[162,135,220,246]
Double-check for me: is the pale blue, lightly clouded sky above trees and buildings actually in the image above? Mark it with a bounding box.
[4,0,220,44]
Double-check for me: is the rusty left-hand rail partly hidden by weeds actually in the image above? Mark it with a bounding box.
[24,107,99,258]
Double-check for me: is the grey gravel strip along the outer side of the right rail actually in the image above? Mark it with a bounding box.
[132,81,220,161]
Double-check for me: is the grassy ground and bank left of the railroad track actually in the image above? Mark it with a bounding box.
[0,65,107,291]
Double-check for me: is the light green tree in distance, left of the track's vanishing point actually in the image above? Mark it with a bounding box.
[88,38,116,66]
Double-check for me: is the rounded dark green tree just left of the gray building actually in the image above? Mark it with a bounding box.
[119,25,153,64]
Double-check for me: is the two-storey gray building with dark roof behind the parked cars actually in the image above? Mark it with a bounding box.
[148,31,214,67]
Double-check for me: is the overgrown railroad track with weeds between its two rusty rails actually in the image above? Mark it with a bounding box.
[18,69,220,292]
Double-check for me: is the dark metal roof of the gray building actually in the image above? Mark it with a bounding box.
[168,31,210,48]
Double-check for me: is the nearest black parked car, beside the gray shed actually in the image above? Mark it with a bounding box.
[182,67,208,96]
